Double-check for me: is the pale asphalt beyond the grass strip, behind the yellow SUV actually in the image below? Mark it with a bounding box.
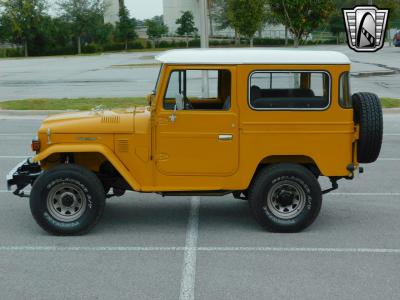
[0,45,400,101]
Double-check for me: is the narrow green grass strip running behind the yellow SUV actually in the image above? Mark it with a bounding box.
[0,97,400,110]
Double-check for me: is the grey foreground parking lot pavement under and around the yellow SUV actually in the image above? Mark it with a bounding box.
[0,113,400,299]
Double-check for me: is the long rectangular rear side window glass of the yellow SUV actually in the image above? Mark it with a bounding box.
[249,71,331,110]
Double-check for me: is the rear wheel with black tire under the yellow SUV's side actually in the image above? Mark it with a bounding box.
[249,163,322,232]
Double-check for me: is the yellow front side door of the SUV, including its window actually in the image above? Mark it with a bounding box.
[155,67,239,176]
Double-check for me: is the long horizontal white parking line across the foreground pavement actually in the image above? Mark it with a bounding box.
[0,246,400,254]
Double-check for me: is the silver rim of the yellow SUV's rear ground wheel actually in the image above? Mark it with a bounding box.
[267,180,306,219]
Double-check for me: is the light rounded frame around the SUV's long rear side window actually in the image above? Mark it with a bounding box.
[247,69,332,111]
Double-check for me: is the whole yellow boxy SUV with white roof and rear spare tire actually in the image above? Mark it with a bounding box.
[7,49,383,235]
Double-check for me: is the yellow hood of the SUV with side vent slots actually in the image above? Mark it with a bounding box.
[39,107,150,134]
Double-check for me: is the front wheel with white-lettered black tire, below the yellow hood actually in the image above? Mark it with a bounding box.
[30,164,105,235]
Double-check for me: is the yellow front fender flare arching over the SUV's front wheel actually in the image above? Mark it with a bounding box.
[33,144,141,191]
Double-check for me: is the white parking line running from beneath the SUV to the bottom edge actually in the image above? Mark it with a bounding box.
[179,196,200,300]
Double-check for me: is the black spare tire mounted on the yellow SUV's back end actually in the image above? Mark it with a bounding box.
[352,93,383,163]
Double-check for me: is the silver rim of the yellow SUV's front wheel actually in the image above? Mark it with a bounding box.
[47,183,87,222]
